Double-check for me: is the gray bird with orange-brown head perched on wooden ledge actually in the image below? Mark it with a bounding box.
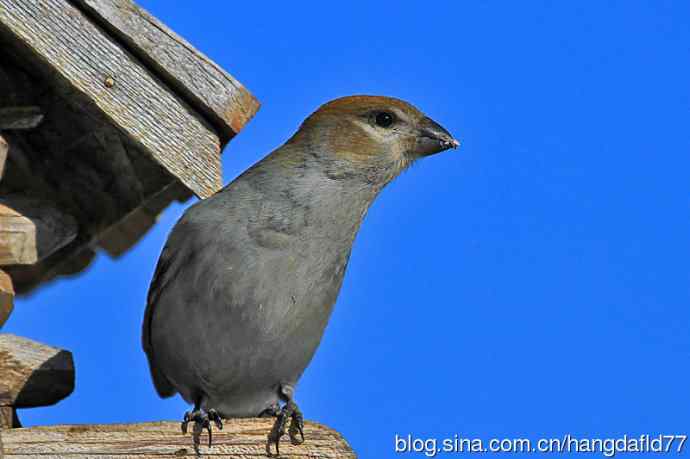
[142,95,459,456]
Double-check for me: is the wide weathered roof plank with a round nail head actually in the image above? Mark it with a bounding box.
[0,0,221,198]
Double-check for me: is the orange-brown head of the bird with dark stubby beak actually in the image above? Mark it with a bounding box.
[291,96,459,184]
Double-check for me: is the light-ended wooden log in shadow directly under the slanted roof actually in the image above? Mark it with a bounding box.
[0,196,78,265]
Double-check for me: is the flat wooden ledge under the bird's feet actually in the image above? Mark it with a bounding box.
[0,418,356,459]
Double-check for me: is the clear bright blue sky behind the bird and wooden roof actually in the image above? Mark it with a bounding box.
[3,0,690,458]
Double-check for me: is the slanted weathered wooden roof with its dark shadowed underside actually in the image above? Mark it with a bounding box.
[0,0,258,293]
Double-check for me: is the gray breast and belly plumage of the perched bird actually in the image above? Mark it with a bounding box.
[147,146,373,417]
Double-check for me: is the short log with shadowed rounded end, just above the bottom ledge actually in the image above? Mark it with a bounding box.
[0,333,74,408]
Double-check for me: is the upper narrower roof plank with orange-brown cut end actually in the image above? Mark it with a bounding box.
[73,0,259,142]
